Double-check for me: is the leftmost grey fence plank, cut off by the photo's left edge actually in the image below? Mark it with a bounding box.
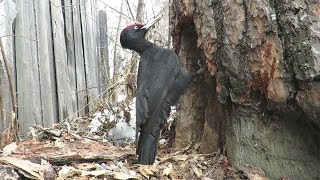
[0,0,17,134]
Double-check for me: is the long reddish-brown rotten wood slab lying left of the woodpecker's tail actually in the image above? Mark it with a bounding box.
[10,139,134,165]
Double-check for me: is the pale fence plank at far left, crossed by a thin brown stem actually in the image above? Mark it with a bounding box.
[0,0,17,132]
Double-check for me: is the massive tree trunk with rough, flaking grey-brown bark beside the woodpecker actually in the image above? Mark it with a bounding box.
[171,0,320,179]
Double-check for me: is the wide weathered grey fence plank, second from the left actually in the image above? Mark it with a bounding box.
[15,0,42,134]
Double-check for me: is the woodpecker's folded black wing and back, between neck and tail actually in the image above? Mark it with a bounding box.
[137,48,179,126]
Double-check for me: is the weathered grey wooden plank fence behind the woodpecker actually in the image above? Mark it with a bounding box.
[0,0,107,134]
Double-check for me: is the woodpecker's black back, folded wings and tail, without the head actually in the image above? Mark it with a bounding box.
[136,47,180,164]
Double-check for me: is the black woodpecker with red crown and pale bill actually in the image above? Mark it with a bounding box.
[120,21,191,164]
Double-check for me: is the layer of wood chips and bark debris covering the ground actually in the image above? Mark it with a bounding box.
[0,121,267,180]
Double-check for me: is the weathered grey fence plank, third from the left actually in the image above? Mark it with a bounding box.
[35,1,58,127]
